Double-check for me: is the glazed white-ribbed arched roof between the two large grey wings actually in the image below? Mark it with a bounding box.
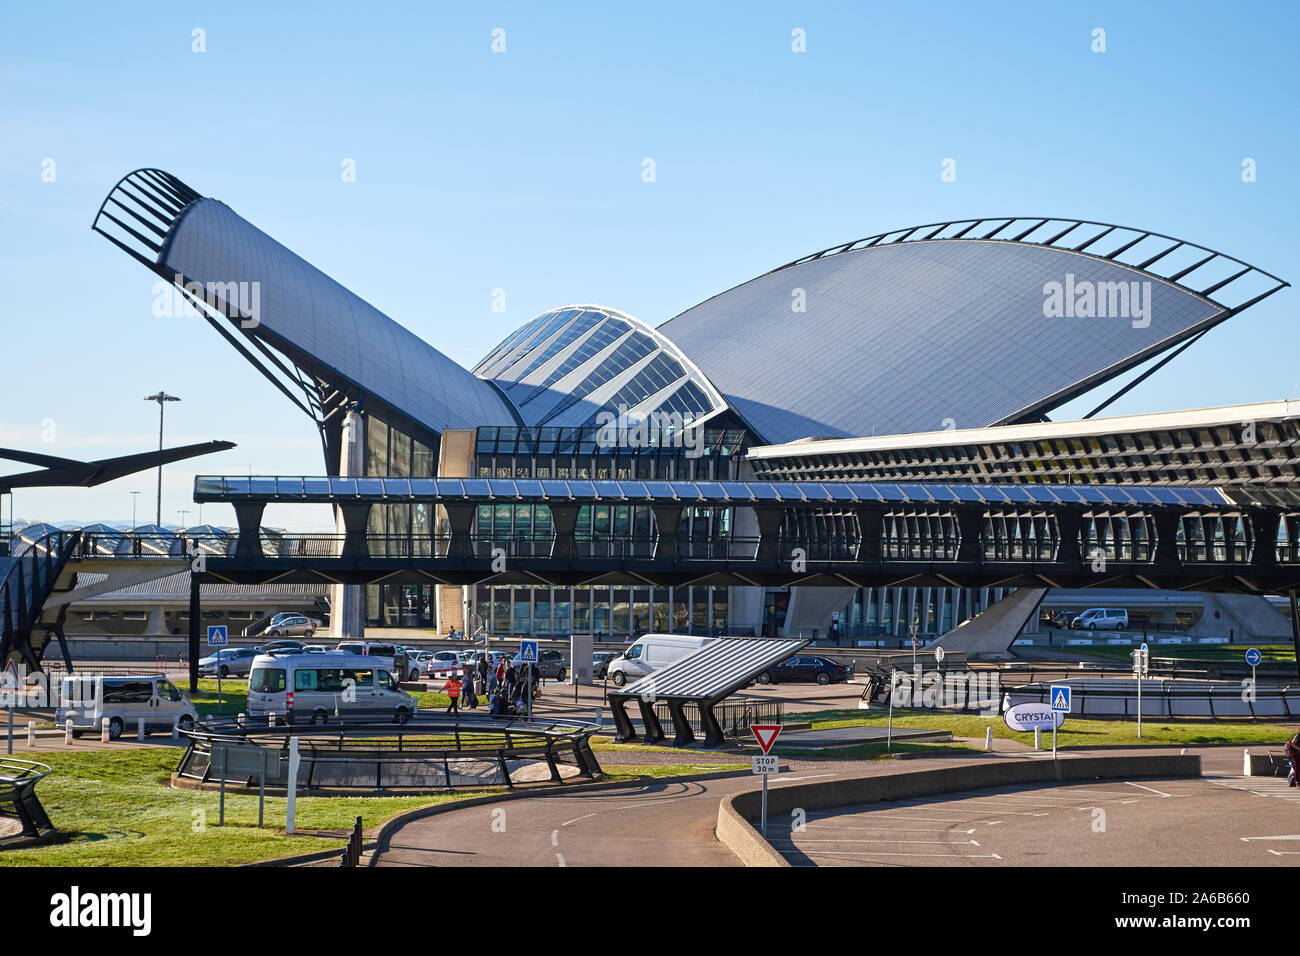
[473,306,727,427]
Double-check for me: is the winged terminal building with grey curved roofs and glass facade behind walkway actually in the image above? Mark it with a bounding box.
[94,169,1300,639]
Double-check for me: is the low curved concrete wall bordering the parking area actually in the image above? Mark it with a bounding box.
[716,753,1201,866]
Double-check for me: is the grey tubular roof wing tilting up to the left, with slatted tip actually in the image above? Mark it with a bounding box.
[94,169,519,433]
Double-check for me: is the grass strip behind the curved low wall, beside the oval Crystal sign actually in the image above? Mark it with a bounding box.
[777,709,1295,754]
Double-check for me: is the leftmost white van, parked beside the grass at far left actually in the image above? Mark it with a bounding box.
[55,674,199,740]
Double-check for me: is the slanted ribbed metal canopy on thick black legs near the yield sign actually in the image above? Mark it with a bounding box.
[607,637,811,747]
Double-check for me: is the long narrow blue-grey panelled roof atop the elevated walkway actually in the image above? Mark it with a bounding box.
[194,475,1234,509]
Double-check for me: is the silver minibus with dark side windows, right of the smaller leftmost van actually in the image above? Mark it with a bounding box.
[248,650,416,723]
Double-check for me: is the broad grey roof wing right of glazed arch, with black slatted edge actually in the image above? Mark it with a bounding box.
[659,219,1286,444]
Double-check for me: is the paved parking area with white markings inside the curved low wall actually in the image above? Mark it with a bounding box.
[768,777,1300,866]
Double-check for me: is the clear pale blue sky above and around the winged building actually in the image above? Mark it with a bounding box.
[0,3,1300,523]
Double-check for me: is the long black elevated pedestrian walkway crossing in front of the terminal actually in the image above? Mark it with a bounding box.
[183,476,1300,593]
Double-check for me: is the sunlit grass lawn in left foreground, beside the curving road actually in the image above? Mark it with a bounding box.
[0,749,501,866]
